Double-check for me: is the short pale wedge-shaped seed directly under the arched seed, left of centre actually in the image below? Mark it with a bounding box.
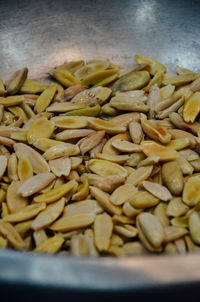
[49,156,71,177]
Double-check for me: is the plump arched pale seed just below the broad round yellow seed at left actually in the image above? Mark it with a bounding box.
[43,143,80,160]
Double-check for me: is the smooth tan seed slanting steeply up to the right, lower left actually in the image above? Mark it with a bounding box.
[32,197,65,230]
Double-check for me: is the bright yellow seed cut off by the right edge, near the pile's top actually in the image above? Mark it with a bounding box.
[183,92,200,123]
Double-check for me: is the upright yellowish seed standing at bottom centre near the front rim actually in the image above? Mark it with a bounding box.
[94,213,113,252]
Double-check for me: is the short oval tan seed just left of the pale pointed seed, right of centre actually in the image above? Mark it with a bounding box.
[110,184,138,206]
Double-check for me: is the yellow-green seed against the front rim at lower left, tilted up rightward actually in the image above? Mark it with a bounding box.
[35,234,64,254]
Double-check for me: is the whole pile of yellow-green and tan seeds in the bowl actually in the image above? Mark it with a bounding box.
[0,55,200,257]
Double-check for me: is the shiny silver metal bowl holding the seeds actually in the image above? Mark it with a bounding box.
[0,0,200,301]
